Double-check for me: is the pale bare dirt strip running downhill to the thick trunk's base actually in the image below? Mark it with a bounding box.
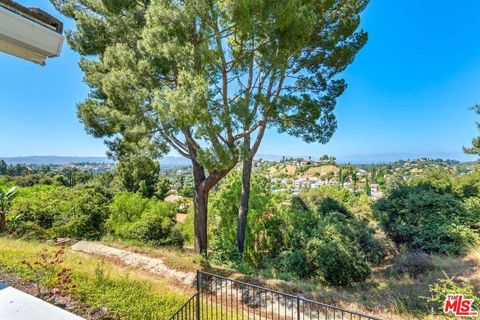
[71,241,196,285]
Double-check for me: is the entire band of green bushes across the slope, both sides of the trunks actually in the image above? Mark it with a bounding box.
[0,161,480,318]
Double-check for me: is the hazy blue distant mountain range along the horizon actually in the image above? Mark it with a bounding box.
[0,152,478,167]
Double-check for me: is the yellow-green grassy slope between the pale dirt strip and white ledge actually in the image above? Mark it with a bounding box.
[0,238,188,319]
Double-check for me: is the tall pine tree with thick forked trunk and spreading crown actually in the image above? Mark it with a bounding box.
[51,0,367,254]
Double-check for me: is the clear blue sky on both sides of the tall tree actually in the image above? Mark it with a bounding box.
[0,0,480,159]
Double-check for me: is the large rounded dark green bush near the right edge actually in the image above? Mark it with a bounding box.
[375,180,479,254]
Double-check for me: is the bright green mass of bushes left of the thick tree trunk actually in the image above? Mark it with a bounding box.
[0,159,184,246]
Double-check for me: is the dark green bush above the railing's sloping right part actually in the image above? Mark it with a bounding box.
[275,200,385,285]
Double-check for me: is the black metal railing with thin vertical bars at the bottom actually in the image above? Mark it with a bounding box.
[170,271,379,320]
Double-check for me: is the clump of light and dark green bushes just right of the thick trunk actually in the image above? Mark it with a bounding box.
[211,179,386,285]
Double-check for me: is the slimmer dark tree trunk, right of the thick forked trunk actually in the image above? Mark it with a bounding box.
[236,157,253,254]
